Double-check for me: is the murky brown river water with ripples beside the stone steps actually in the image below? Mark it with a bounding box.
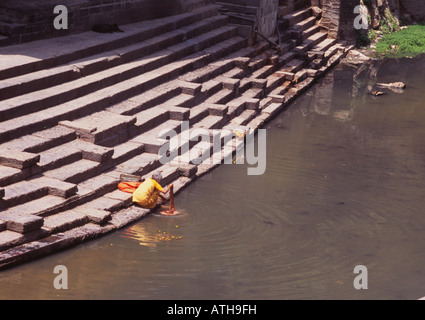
[0,57,425,300]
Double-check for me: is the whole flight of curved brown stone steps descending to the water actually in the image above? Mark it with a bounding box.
[0,5,347,268]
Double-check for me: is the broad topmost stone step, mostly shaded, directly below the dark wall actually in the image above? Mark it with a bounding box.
[0,5,218,80]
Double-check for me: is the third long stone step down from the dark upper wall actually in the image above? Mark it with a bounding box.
[0,26,237,121]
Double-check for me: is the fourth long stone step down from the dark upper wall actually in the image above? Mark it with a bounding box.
[0,37,246,142]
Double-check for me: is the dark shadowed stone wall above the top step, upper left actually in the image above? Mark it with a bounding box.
[0,0,213,43]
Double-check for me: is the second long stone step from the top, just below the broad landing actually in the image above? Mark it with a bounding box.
[0,16,227,100]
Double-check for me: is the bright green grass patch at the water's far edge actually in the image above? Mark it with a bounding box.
[376,23,425,57]
